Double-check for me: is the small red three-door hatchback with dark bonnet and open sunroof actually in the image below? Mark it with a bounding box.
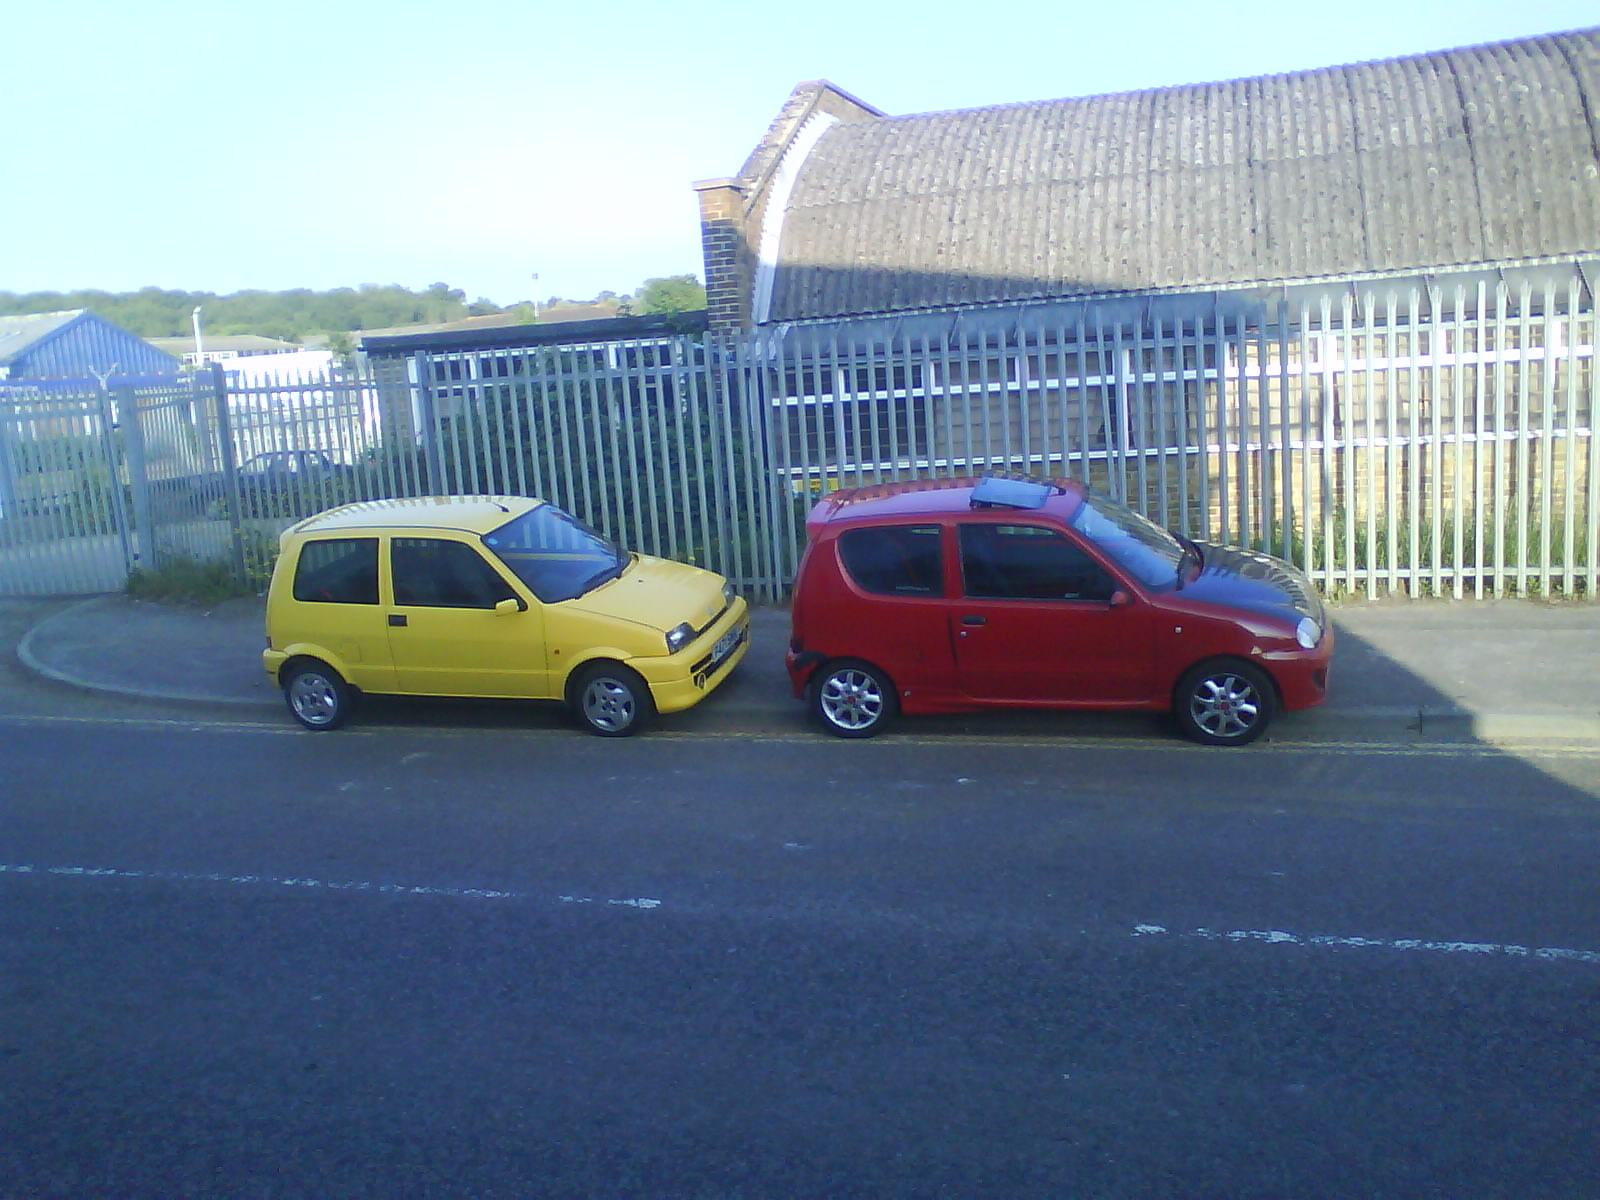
[787,478,1333,746]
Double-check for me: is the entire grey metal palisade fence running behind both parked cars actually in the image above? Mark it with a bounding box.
[0,269,1600,602]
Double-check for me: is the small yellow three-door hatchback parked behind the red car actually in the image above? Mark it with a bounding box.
[261,496,750,738]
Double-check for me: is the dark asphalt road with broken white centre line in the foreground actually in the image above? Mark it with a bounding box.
[0,688,1600,1198]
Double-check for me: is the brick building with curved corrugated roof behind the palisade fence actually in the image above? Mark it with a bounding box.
[696,29,1600,569]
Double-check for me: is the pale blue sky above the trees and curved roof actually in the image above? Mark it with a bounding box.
[0,0,1600,304]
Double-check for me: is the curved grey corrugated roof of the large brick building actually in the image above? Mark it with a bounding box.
[768,29,1600,322]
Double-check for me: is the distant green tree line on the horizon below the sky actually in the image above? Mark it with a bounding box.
[0,275,706,342]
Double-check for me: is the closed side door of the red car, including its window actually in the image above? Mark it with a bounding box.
[947,522,1155,706]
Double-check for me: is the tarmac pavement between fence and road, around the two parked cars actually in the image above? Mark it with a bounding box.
[16,595,1600,744]
